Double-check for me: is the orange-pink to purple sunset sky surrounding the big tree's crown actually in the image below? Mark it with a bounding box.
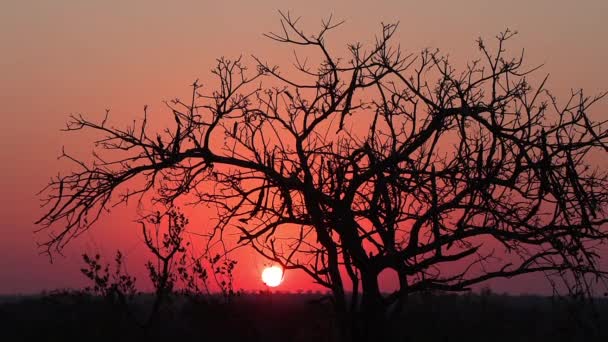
[0,0,608,294]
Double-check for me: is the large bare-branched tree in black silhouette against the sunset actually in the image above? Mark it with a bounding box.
[38,13,608,335]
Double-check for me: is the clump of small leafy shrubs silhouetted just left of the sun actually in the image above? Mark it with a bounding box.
[79,208,240,337]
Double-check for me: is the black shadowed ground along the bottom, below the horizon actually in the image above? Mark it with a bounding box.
[0,292,608,342]
